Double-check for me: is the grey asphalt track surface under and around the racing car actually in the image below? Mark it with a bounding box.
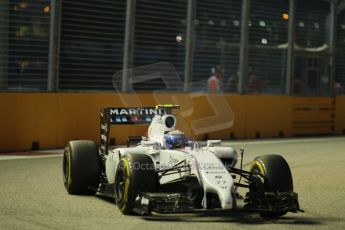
[0,137,345,230]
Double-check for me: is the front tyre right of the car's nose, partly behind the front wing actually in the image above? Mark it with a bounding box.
[249,155,293,218]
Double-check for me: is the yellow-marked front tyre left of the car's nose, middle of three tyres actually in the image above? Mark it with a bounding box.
[115,154,158,215]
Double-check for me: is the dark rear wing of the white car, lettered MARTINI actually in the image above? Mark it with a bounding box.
[100,105,180,155]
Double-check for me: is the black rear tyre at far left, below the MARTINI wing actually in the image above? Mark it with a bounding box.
[63,140,100,195]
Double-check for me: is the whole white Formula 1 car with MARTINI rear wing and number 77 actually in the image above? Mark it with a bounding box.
[63,105,301,217]
